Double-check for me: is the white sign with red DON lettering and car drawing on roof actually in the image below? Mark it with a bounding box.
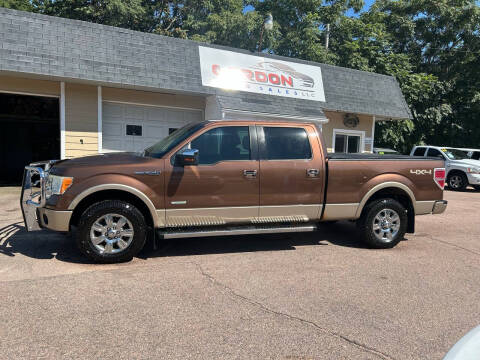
[199,46,325,101]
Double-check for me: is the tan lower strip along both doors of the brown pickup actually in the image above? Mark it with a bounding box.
[161,204,322,227]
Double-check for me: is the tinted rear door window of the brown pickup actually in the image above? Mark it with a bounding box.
[262,126,312,160]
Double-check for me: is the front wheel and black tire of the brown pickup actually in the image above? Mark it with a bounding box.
[76,200,147,263]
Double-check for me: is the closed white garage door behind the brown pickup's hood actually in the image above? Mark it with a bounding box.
[102,102,203,152]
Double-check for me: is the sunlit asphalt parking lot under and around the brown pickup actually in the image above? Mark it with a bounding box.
[0,188,480,359]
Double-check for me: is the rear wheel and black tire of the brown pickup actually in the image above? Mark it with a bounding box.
[357,198,408,249]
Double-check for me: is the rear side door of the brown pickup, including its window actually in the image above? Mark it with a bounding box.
[257,125,325,223]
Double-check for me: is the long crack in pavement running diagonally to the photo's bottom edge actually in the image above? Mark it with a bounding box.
[192,262,394,360]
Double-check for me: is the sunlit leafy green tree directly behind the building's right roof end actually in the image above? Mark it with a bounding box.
[324,11,451,152]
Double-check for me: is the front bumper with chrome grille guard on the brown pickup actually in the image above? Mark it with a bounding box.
[20,161,72,231]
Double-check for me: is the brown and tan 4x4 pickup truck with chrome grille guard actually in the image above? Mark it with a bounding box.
[21,120,447,262]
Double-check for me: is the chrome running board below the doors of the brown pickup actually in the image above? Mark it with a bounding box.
[157,224,317,239]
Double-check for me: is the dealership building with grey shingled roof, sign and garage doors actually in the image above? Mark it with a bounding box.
[0,8,411,184]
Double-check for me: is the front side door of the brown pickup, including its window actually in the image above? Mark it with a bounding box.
[165,123,259,227]
